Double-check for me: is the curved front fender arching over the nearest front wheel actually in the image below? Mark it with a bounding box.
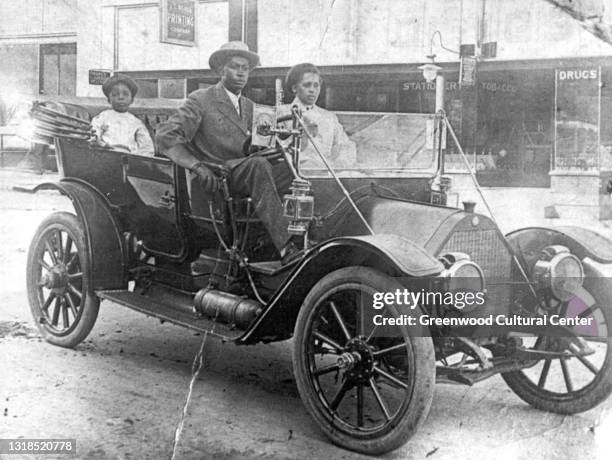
[237,235,444,344]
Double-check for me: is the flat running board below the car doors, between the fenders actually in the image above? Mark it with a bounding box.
[96,286,244,341]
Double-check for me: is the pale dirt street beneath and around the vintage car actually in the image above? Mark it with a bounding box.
[0,172,612,460]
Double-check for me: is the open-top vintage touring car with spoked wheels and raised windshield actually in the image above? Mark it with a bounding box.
[27,99,612,454]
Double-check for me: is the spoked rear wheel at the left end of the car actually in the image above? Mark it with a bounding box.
[27,212,100,348]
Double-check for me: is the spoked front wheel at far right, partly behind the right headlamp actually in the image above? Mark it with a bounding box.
[502,291,612,414]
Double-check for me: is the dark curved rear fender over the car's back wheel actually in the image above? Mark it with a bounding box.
[33,178,127,290]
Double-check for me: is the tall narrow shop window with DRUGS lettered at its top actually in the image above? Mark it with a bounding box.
[555,67,601,171]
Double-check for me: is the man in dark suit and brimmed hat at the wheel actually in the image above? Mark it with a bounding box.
[156,42,297,262]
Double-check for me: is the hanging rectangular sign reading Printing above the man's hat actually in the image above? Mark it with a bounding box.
[160,0,196,46]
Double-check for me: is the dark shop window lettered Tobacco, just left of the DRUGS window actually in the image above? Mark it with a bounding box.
[464,69,554,187]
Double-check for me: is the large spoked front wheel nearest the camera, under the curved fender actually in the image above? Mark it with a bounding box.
[293,267,435,454]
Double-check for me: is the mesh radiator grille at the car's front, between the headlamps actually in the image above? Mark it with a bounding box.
[440,229,512,281]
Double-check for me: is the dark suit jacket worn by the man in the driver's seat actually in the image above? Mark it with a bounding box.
[155,82,253,163]
